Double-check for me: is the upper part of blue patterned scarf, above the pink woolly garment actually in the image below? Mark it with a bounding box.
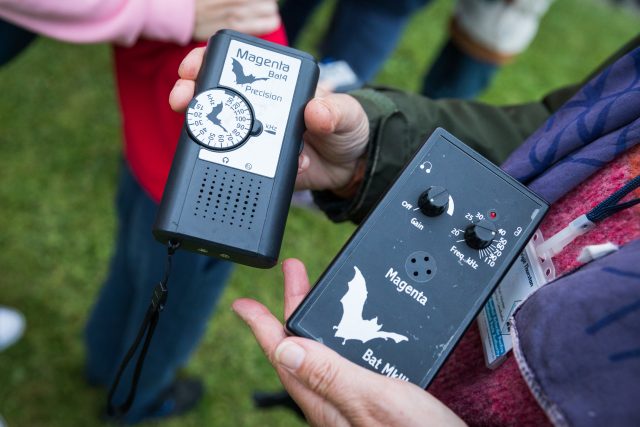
[502,48,640,203]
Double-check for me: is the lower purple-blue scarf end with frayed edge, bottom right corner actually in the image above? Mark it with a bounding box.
[514,240,640,426]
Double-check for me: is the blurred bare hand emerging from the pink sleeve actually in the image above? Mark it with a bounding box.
[193,0,280,40]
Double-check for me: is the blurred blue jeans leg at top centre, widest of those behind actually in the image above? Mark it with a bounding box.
[318,0,429,82]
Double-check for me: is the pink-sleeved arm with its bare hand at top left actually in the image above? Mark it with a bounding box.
[0,0,280,46]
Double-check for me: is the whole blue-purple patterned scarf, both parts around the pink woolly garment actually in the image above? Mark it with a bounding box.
[503,48,640,426]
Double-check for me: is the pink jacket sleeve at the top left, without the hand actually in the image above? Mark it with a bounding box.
[0,0,195,46]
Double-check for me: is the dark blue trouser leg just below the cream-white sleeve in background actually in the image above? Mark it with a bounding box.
[422,39,500,99]
